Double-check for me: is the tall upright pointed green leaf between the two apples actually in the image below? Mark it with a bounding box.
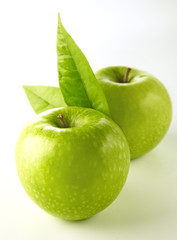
[57,14,110,115]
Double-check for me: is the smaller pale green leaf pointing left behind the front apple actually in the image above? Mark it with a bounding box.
[23,85,66,114]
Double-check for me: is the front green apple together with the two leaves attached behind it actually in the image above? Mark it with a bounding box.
[16,16,130,220]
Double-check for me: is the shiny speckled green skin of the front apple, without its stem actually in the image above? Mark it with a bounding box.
[16,107,130,220]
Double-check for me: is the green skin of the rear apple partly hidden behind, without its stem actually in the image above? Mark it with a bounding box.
[96,66,172,159]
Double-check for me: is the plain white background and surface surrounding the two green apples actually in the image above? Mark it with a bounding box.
[0,0,177,240]
